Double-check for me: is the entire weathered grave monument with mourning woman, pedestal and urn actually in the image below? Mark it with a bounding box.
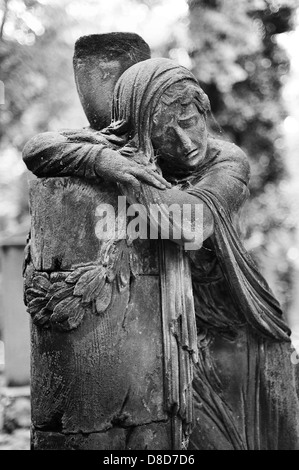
[24,34,299,450]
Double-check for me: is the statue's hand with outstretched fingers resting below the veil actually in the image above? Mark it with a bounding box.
[95,148,171,193]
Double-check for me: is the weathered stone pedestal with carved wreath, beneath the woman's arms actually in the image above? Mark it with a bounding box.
[25,178,196,450]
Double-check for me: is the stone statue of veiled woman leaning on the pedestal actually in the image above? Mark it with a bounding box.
[24,36,299,450]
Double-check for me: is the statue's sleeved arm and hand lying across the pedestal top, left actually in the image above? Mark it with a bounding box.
[23,130,171,190]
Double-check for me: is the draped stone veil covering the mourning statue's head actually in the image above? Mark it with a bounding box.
[106,58,210,162]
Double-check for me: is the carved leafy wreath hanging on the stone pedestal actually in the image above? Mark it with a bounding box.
[25,240,138,331]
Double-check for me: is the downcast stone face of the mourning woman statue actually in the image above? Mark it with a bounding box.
[152,86,208,169]
